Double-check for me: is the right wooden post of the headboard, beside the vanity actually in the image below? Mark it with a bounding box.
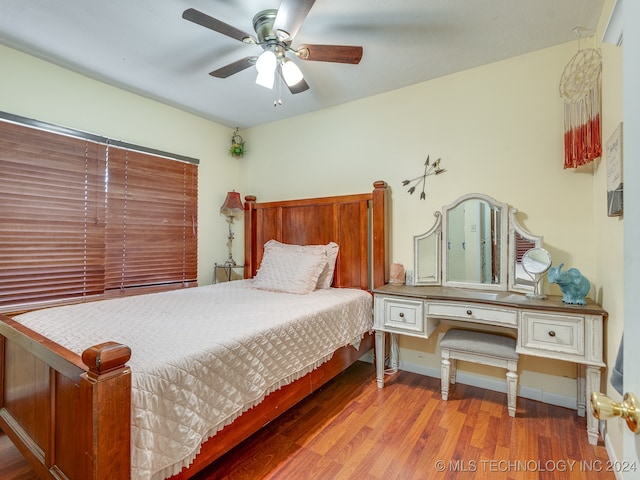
[371,180,389,288]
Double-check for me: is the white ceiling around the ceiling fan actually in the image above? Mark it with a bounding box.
[0,0,605,128]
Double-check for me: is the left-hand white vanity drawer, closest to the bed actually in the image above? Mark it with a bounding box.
[374,295,427,337]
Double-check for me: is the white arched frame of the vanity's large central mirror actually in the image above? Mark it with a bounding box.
[441,193,509,291]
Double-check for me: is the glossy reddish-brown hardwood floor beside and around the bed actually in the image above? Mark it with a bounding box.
[0,362,615,480]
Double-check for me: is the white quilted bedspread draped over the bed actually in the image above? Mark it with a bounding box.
[15,280,373,480]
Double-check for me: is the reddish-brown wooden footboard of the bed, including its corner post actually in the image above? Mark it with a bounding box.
[0,315,131,480]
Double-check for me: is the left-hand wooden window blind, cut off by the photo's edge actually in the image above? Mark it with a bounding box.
[0,122,105,305]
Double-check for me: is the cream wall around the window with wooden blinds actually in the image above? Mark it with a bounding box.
[0,46,245,284]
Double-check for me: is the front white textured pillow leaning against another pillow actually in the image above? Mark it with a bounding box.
[253,248,327,295]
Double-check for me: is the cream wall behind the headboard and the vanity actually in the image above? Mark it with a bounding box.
[246,42,613,406]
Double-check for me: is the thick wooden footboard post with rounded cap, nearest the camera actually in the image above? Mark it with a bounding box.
[80,342,131,480]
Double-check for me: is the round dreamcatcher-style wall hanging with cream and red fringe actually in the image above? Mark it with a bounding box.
[560,29,602,168]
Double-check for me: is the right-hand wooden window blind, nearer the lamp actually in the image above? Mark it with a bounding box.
[105,147,197,289]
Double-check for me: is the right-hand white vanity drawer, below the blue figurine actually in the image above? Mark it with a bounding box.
[519,311,584,357]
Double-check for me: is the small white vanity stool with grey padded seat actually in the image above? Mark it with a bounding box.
[440,328,518,417]
